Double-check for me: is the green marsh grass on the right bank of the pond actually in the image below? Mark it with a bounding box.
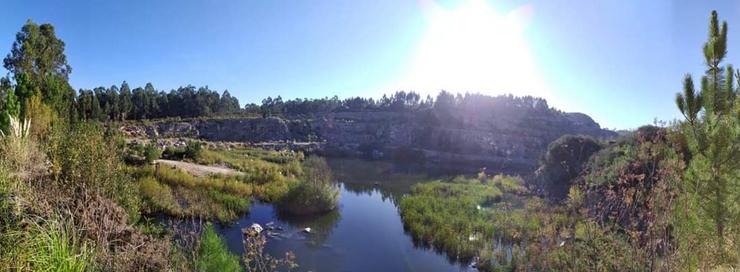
[399,176,649,271]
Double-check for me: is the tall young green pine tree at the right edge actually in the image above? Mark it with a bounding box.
[676,11,740,244]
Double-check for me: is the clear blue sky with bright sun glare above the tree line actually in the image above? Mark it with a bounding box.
[0,0,740,129]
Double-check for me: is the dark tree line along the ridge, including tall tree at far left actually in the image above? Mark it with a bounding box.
[0,20,554,131]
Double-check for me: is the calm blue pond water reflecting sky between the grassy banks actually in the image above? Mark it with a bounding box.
[212,159,474,272]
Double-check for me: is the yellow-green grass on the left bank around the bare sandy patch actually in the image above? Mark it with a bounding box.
[134,147,310,221]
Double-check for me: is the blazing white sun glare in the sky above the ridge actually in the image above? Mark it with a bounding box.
[398,0,545,99]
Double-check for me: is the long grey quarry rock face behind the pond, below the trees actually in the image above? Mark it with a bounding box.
[122,110,616,174]
